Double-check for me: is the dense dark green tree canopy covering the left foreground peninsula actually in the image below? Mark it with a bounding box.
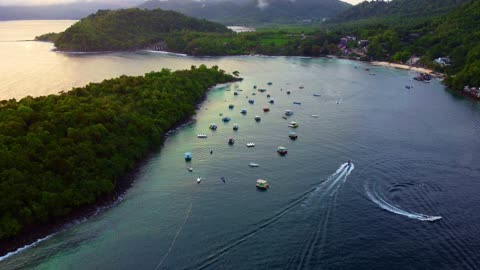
[0,65,234,239]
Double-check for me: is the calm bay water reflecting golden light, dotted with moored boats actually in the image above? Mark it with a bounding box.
[0,21,480,269]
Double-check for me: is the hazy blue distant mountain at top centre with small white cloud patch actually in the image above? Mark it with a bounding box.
[139,0,351,25]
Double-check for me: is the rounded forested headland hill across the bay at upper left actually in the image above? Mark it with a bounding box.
[55,8,231,52]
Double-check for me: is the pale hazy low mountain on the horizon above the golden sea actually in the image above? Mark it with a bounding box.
[0,2,124,21]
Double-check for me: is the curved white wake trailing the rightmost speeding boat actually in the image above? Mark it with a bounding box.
[364,179,442,222]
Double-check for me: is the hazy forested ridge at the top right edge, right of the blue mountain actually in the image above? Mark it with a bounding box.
[333,0,471,22]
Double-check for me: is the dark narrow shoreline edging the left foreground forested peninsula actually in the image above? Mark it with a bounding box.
[0,78,243,261]
